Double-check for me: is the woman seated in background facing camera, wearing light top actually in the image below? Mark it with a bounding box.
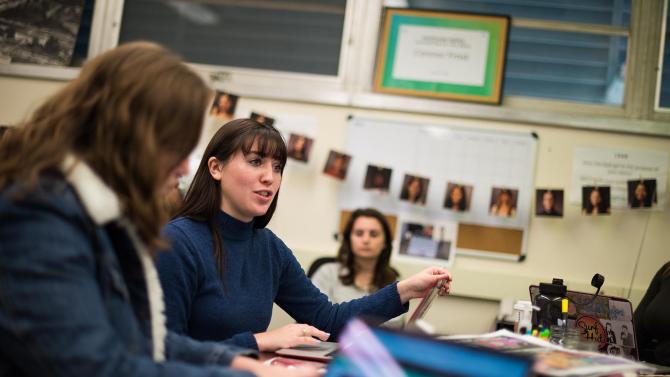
[312,208,403,327]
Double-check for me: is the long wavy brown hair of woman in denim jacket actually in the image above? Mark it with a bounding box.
[0,42,211,250]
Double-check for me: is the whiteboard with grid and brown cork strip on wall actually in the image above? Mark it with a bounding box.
[340,117,537,260]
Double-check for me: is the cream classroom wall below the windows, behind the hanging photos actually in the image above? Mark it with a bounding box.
[0,77,670,333]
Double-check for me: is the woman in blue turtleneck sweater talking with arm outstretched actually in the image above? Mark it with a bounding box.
[158,119,451,351]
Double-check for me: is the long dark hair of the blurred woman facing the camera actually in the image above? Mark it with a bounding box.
[337,208,398,290]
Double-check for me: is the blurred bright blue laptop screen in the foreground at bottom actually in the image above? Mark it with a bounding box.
[326,319,532,377]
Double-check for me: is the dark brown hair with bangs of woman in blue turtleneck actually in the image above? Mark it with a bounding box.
[175,119,287,277]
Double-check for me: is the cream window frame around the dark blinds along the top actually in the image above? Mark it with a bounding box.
[0,0,670,137]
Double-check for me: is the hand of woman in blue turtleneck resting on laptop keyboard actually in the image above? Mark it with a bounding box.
[254,323,330,352]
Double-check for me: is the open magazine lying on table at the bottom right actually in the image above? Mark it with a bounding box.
[440,330,653,377]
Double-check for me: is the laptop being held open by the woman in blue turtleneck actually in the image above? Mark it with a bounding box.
[275,280,444,362]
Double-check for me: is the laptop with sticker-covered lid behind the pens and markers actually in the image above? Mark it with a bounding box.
[529,285,639,360]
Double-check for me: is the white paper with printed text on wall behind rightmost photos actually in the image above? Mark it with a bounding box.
[570,146,668,208]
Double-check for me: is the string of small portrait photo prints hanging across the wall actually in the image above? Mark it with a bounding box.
[210,91,657,217]
